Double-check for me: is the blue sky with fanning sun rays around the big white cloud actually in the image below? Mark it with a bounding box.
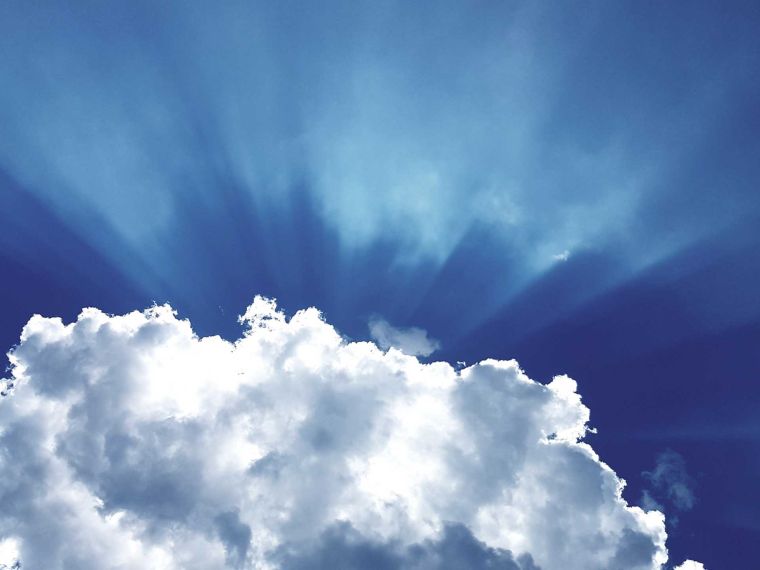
[0,0,760,568]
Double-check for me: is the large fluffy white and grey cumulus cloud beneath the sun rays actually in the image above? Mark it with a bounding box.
[0,298,696,570]
